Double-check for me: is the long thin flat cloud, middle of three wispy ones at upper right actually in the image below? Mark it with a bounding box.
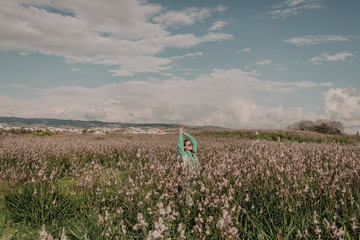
[284,35,351,46]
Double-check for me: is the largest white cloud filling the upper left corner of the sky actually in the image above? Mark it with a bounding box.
[0,0,233,76]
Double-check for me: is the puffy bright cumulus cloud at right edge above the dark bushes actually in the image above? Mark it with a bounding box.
[320,88,360,133]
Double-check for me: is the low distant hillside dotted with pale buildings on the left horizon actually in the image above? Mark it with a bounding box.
[0,117,226,130]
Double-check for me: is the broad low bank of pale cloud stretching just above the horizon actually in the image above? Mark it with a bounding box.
[0,69,334,128]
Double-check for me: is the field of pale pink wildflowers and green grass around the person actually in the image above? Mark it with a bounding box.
[0,131,360,240]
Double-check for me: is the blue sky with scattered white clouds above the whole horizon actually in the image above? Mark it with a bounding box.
[0,0,360,133]
